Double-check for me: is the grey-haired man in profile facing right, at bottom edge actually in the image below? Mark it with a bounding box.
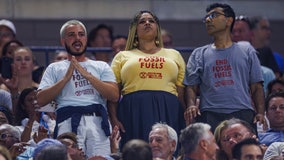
[179,123,219,160]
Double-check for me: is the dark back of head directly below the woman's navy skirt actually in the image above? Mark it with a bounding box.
[122,139,153,160]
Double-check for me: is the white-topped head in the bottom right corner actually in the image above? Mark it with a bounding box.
[263,142,284,160]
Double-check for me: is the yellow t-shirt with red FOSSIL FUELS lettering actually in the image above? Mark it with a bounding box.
[111,48,185,95]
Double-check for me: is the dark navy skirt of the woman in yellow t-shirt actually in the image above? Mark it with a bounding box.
[118,91,185,146]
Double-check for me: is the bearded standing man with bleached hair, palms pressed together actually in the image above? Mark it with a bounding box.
[37,20,119,158]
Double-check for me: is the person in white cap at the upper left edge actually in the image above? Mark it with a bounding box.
[0,19,16,58]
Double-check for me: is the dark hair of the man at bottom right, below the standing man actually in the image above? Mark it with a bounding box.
[232,138,262,160]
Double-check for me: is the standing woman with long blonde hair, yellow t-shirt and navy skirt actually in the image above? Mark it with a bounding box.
[109,11,185,148]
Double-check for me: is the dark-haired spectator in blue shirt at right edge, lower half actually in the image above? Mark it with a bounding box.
[258,92,284,146]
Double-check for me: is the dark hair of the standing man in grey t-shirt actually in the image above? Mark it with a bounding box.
[206,3,236,32]
